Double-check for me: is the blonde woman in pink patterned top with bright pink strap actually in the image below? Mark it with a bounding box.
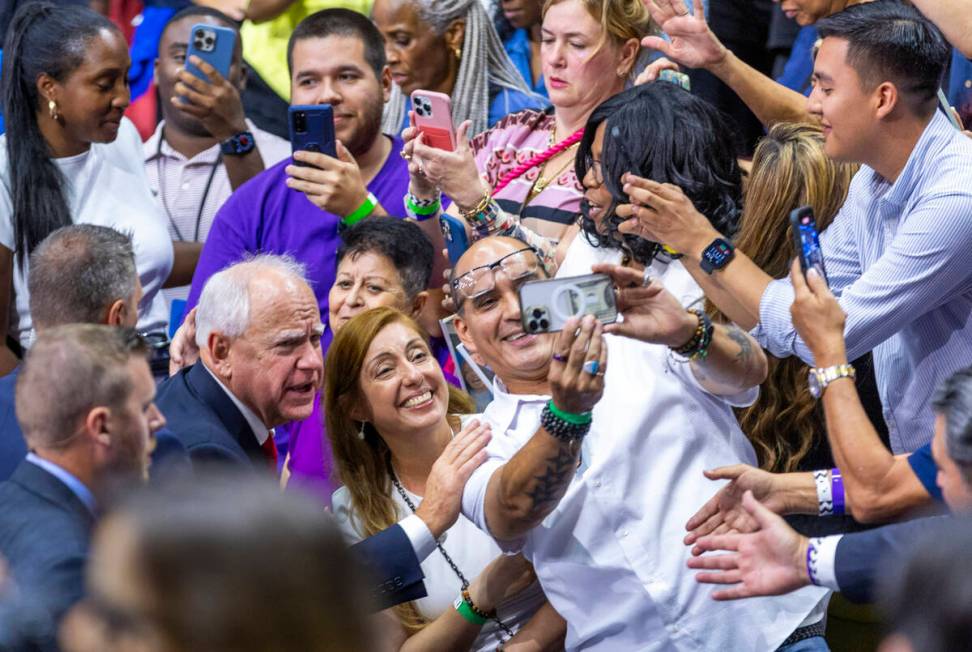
[402,0,651,269]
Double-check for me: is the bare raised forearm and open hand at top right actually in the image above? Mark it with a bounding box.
[641,0,815,127]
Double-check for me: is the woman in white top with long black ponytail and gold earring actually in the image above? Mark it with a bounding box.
[0,2,172,373]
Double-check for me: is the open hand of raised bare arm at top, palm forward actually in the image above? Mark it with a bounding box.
[641,0,728,68]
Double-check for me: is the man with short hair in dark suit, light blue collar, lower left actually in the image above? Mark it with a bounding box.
[0,324,165,640]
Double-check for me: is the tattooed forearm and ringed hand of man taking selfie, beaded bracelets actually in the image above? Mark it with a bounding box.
[485,315,607,540]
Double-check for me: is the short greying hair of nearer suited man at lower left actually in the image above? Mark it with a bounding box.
[15,324,149,449]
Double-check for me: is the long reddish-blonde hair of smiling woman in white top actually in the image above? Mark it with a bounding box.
[324,307,475,635]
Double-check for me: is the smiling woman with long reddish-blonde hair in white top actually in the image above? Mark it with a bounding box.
[324,308,566,650]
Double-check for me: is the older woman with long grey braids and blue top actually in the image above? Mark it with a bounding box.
[372,0,547,134]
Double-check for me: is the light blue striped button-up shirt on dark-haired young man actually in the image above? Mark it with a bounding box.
[753,111,972,453]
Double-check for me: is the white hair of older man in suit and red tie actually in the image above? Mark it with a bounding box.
[196,254,310,348]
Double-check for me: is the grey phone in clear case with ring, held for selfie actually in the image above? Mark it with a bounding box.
[519,274,618,333]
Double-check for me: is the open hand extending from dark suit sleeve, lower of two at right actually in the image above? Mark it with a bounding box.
[688,491,810,600]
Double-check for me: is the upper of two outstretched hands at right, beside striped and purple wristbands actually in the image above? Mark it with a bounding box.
[684,464,785,555]
